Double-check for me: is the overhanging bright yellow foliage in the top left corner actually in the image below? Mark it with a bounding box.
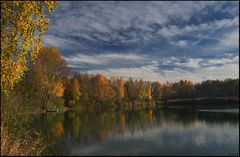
[1,1,57,93]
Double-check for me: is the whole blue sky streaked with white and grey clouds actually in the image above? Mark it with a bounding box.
[43,1,239,82]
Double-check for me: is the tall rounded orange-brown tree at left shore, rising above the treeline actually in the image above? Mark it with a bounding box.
[31,47,68,109]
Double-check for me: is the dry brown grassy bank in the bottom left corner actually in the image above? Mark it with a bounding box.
[1,97,48,156]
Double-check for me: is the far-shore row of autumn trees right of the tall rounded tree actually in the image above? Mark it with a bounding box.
[62,74,239,104]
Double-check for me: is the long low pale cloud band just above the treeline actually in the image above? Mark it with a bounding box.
[65,53,239,82]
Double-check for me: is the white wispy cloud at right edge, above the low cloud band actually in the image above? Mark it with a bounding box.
[158,16,239,55]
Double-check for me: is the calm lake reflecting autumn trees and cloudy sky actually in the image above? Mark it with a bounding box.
[33,108,239,155]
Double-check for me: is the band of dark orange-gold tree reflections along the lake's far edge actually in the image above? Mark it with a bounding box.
[39,109,239,141]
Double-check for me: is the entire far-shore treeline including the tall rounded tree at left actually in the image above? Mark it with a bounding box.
[8,48,239,109]
